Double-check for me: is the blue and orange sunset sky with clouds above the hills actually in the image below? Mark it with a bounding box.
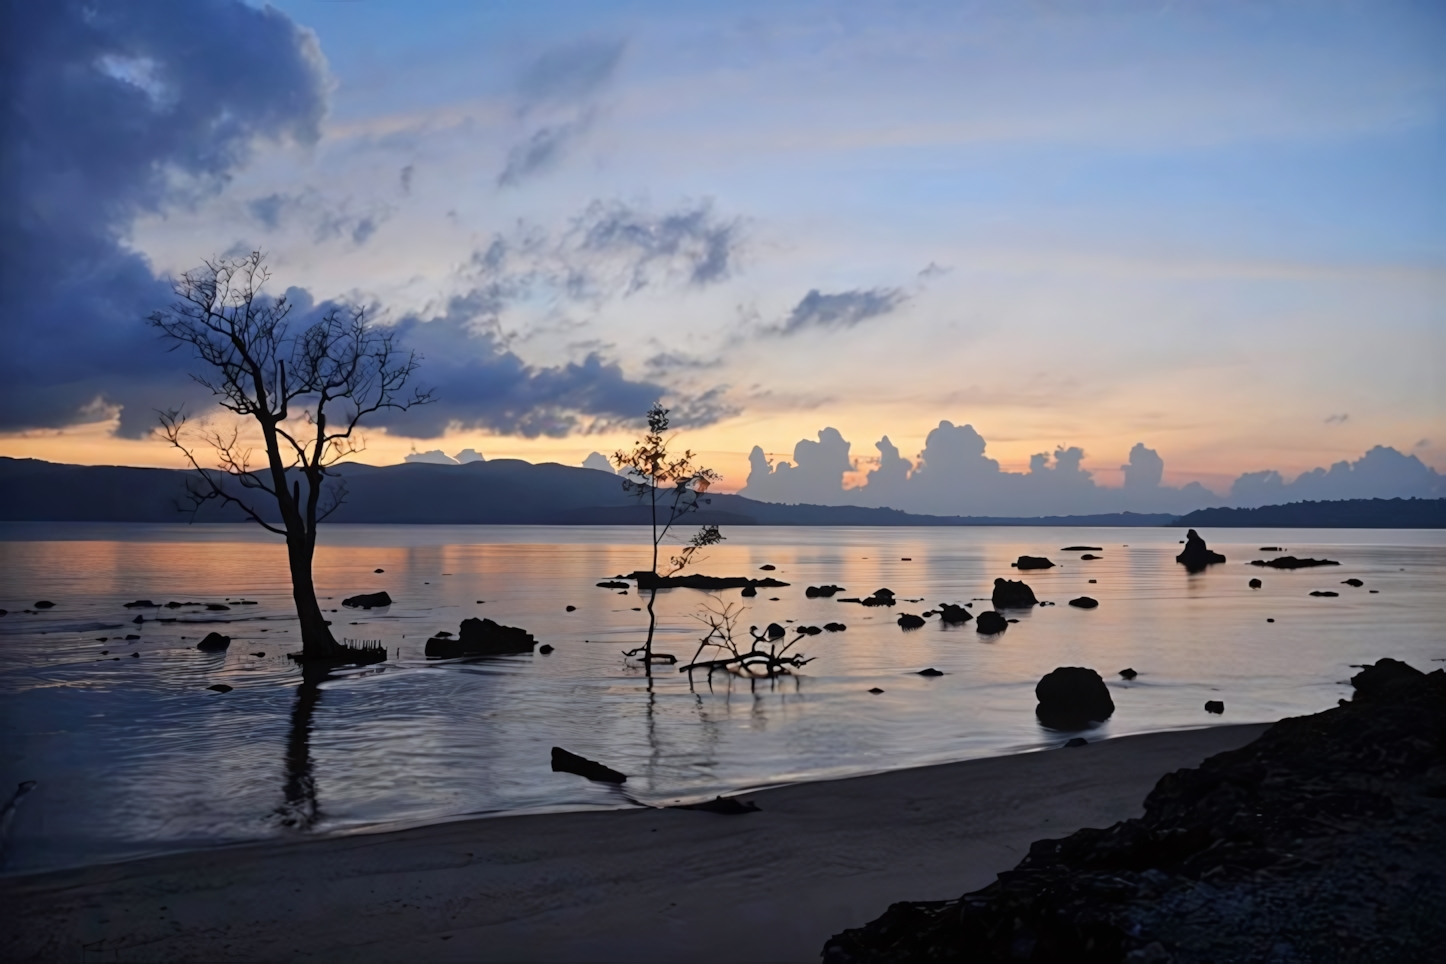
[0,0,1446,512]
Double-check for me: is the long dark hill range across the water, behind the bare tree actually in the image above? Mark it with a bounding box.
[0,458,1174,526]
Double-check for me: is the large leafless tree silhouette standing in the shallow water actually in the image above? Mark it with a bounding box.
[149,251,431,659]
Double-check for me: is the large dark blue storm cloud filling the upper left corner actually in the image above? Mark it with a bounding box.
[0,0,327,435]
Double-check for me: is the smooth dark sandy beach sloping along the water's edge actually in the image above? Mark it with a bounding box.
[0,724,1265,963]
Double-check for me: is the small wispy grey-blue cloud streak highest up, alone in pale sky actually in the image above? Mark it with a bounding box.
[497,40,626,188]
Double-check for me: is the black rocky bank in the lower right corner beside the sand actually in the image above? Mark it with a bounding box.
[824,659,1446,964]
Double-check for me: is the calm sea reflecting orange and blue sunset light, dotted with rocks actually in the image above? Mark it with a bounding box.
[0,523,1446,873]
